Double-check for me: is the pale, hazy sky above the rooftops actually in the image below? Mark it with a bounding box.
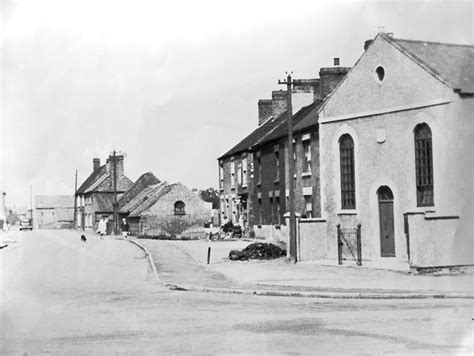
[0,0,474,206]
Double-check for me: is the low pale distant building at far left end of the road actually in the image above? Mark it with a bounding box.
[34,195,74,229]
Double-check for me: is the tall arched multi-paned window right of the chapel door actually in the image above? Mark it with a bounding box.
[415,124,434,206]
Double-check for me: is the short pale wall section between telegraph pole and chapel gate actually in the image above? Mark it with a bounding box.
[297,219,328,261]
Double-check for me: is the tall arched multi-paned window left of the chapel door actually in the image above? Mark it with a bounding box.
[339,134,356,209]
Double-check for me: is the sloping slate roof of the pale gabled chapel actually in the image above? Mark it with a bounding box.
[381,34,474,94]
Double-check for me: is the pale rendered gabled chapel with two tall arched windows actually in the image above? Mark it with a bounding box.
[301,33,474,268]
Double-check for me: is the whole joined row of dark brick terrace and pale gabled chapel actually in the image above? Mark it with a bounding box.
[218,33,474,269]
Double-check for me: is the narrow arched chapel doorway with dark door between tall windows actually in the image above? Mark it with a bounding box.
[377,185,395,257]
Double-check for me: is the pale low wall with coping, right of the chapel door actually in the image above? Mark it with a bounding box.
[408,214,474,268]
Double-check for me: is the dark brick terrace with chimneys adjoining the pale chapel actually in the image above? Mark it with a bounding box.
[219,66,349,239]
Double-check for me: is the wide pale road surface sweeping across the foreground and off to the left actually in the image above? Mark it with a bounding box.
[0,230,474,355]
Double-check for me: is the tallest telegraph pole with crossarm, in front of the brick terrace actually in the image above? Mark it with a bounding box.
[278,72,298,263]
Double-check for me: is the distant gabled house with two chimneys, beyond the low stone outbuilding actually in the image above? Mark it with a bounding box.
[76,154,133,231]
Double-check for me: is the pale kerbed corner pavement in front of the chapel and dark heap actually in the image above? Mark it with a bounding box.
[132,238,474,299]
